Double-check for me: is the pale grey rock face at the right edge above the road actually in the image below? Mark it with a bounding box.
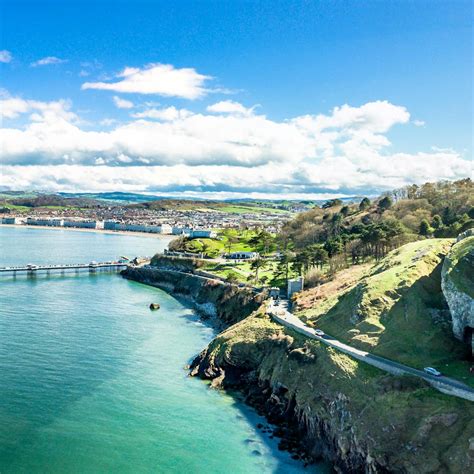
[442,235,474,354]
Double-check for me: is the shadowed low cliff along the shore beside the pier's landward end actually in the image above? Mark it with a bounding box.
[122,264,265,327]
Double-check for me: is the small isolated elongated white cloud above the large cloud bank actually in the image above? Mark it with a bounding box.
[82,63,211,99]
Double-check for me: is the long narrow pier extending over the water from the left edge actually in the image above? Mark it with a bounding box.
[0,261,129,276]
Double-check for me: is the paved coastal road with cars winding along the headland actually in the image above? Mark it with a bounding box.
[267,301,474,402]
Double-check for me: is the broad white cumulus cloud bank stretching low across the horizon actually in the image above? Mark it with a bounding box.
[0,98,471,197]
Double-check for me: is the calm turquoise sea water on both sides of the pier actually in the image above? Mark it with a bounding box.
[0,226,320,473]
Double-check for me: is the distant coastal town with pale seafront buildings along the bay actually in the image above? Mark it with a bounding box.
[0,195,294,238]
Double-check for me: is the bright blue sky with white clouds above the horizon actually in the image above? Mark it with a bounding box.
[0,0,473,199]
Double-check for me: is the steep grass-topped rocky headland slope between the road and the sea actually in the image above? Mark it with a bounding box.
[192,311,474,473]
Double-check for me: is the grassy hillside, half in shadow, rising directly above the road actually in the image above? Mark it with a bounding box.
[297,239,474,386]
